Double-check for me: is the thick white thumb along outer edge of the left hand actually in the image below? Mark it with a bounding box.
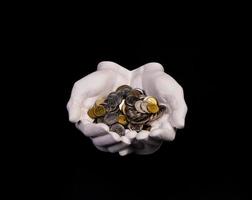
[67,70,114,122]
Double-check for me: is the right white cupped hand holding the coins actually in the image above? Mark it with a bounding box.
[123,63,187,155]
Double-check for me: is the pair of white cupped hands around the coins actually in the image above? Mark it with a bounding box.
[67,61,187,156]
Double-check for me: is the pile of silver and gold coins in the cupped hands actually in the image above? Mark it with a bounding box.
[87,85,166,136]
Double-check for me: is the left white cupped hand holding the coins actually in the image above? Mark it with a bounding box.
[67,62,132,153]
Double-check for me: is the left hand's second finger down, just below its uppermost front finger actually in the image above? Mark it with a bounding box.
[92,134,120,146]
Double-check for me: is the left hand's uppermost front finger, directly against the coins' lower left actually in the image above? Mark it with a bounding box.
[76,122,109,137]
